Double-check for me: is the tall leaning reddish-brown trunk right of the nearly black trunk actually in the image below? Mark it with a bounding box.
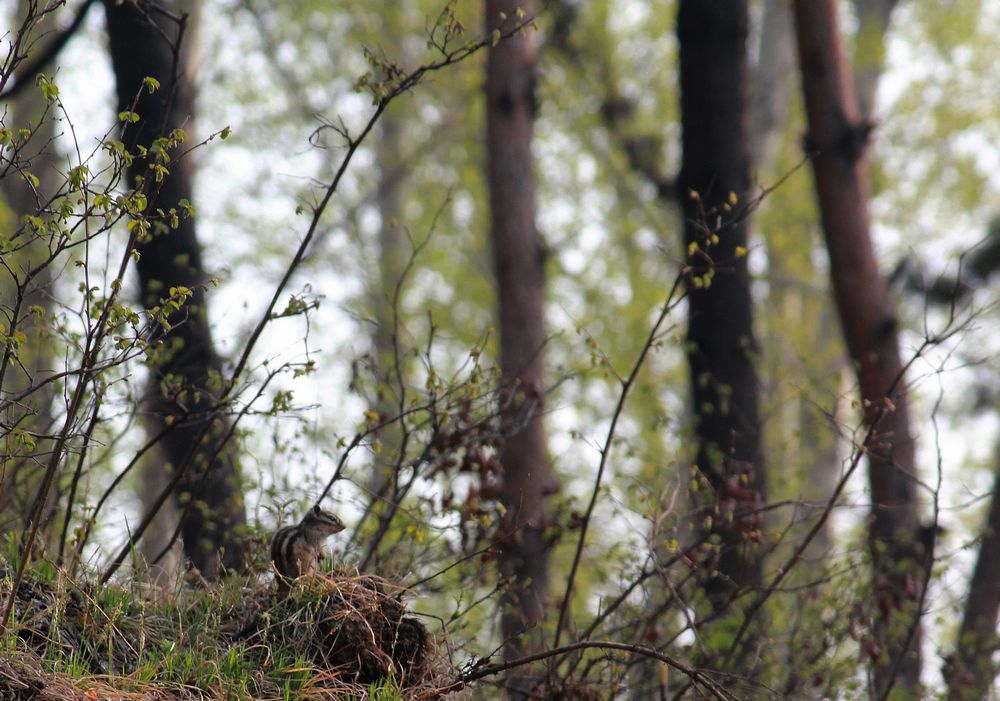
[794,0,929,698]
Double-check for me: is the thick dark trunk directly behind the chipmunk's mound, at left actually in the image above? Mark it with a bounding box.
[105,0,246,578]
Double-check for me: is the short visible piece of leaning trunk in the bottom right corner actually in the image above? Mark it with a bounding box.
[945,445,1000,701]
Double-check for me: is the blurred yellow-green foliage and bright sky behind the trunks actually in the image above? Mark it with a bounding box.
[2,0,1000,686]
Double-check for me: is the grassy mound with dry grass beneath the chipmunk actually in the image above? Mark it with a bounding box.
[0,570,446,701]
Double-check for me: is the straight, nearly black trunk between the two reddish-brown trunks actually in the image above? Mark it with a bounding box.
[677,0,764,611]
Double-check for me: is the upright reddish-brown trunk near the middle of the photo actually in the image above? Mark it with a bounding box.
[486,0,554,697]
